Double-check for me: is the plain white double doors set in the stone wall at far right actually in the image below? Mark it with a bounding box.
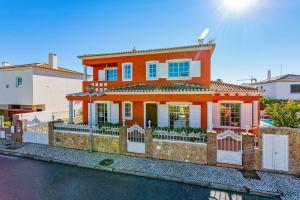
[263,134,288,171]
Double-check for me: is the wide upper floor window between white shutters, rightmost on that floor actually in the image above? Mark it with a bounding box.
[169,61,190,78]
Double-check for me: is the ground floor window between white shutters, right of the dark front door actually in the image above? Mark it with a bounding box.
[169,105,190,128]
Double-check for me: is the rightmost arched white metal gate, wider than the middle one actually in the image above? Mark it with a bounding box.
[217,130,243,165]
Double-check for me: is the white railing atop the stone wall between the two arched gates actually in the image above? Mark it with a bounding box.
[153,128,207,143]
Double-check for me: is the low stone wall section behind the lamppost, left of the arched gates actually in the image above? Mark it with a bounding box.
[53,132,119,153]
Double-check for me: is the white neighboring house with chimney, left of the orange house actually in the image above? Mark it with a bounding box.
[0,53,83,119]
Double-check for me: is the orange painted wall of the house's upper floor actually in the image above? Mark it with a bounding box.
[83,50,212,86]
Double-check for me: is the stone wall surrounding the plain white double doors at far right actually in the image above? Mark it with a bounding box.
[258,127,300,175]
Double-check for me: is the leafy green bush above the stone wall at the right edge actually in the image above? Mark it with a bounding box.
[265,101,300,128]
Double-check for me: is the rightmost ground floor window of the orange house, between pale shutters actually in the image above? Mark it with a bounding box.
[220,103,241,127]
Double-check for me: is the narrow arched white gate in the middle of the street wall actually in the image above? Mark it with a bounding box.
[127,124,145,154]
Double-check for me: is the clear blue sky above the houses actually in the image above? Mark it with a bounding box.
[0,0,300,83]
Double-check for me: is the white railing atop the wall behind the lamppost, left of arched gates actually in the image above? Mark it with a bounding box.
[54,123,119,136]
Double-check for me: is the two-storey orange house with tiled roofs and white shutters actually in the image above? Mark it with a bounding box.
[67,43,261,134]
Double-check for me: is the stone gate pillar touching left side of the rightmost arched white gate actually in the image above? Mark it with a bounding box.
[207,131,218,165]
